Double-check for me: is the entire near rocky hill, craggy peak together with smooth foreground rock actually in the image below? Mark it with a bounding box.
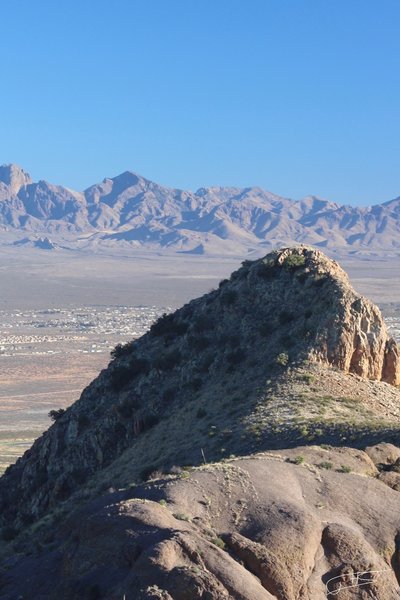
[0,247,400,600]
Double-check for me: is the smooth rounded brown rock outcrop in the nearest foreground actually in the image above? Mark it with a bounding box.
[0,447,400,600]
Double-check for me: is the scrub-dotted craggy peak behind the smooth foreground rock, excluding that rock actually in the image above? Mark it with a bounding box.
[0,247,400,528]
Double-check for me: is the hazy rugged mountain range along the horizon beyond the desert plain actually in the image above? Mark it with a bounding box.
[0,165,400,256]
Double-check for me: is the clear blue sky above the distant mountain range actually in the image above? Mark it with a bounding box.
[0,0,400,205]
